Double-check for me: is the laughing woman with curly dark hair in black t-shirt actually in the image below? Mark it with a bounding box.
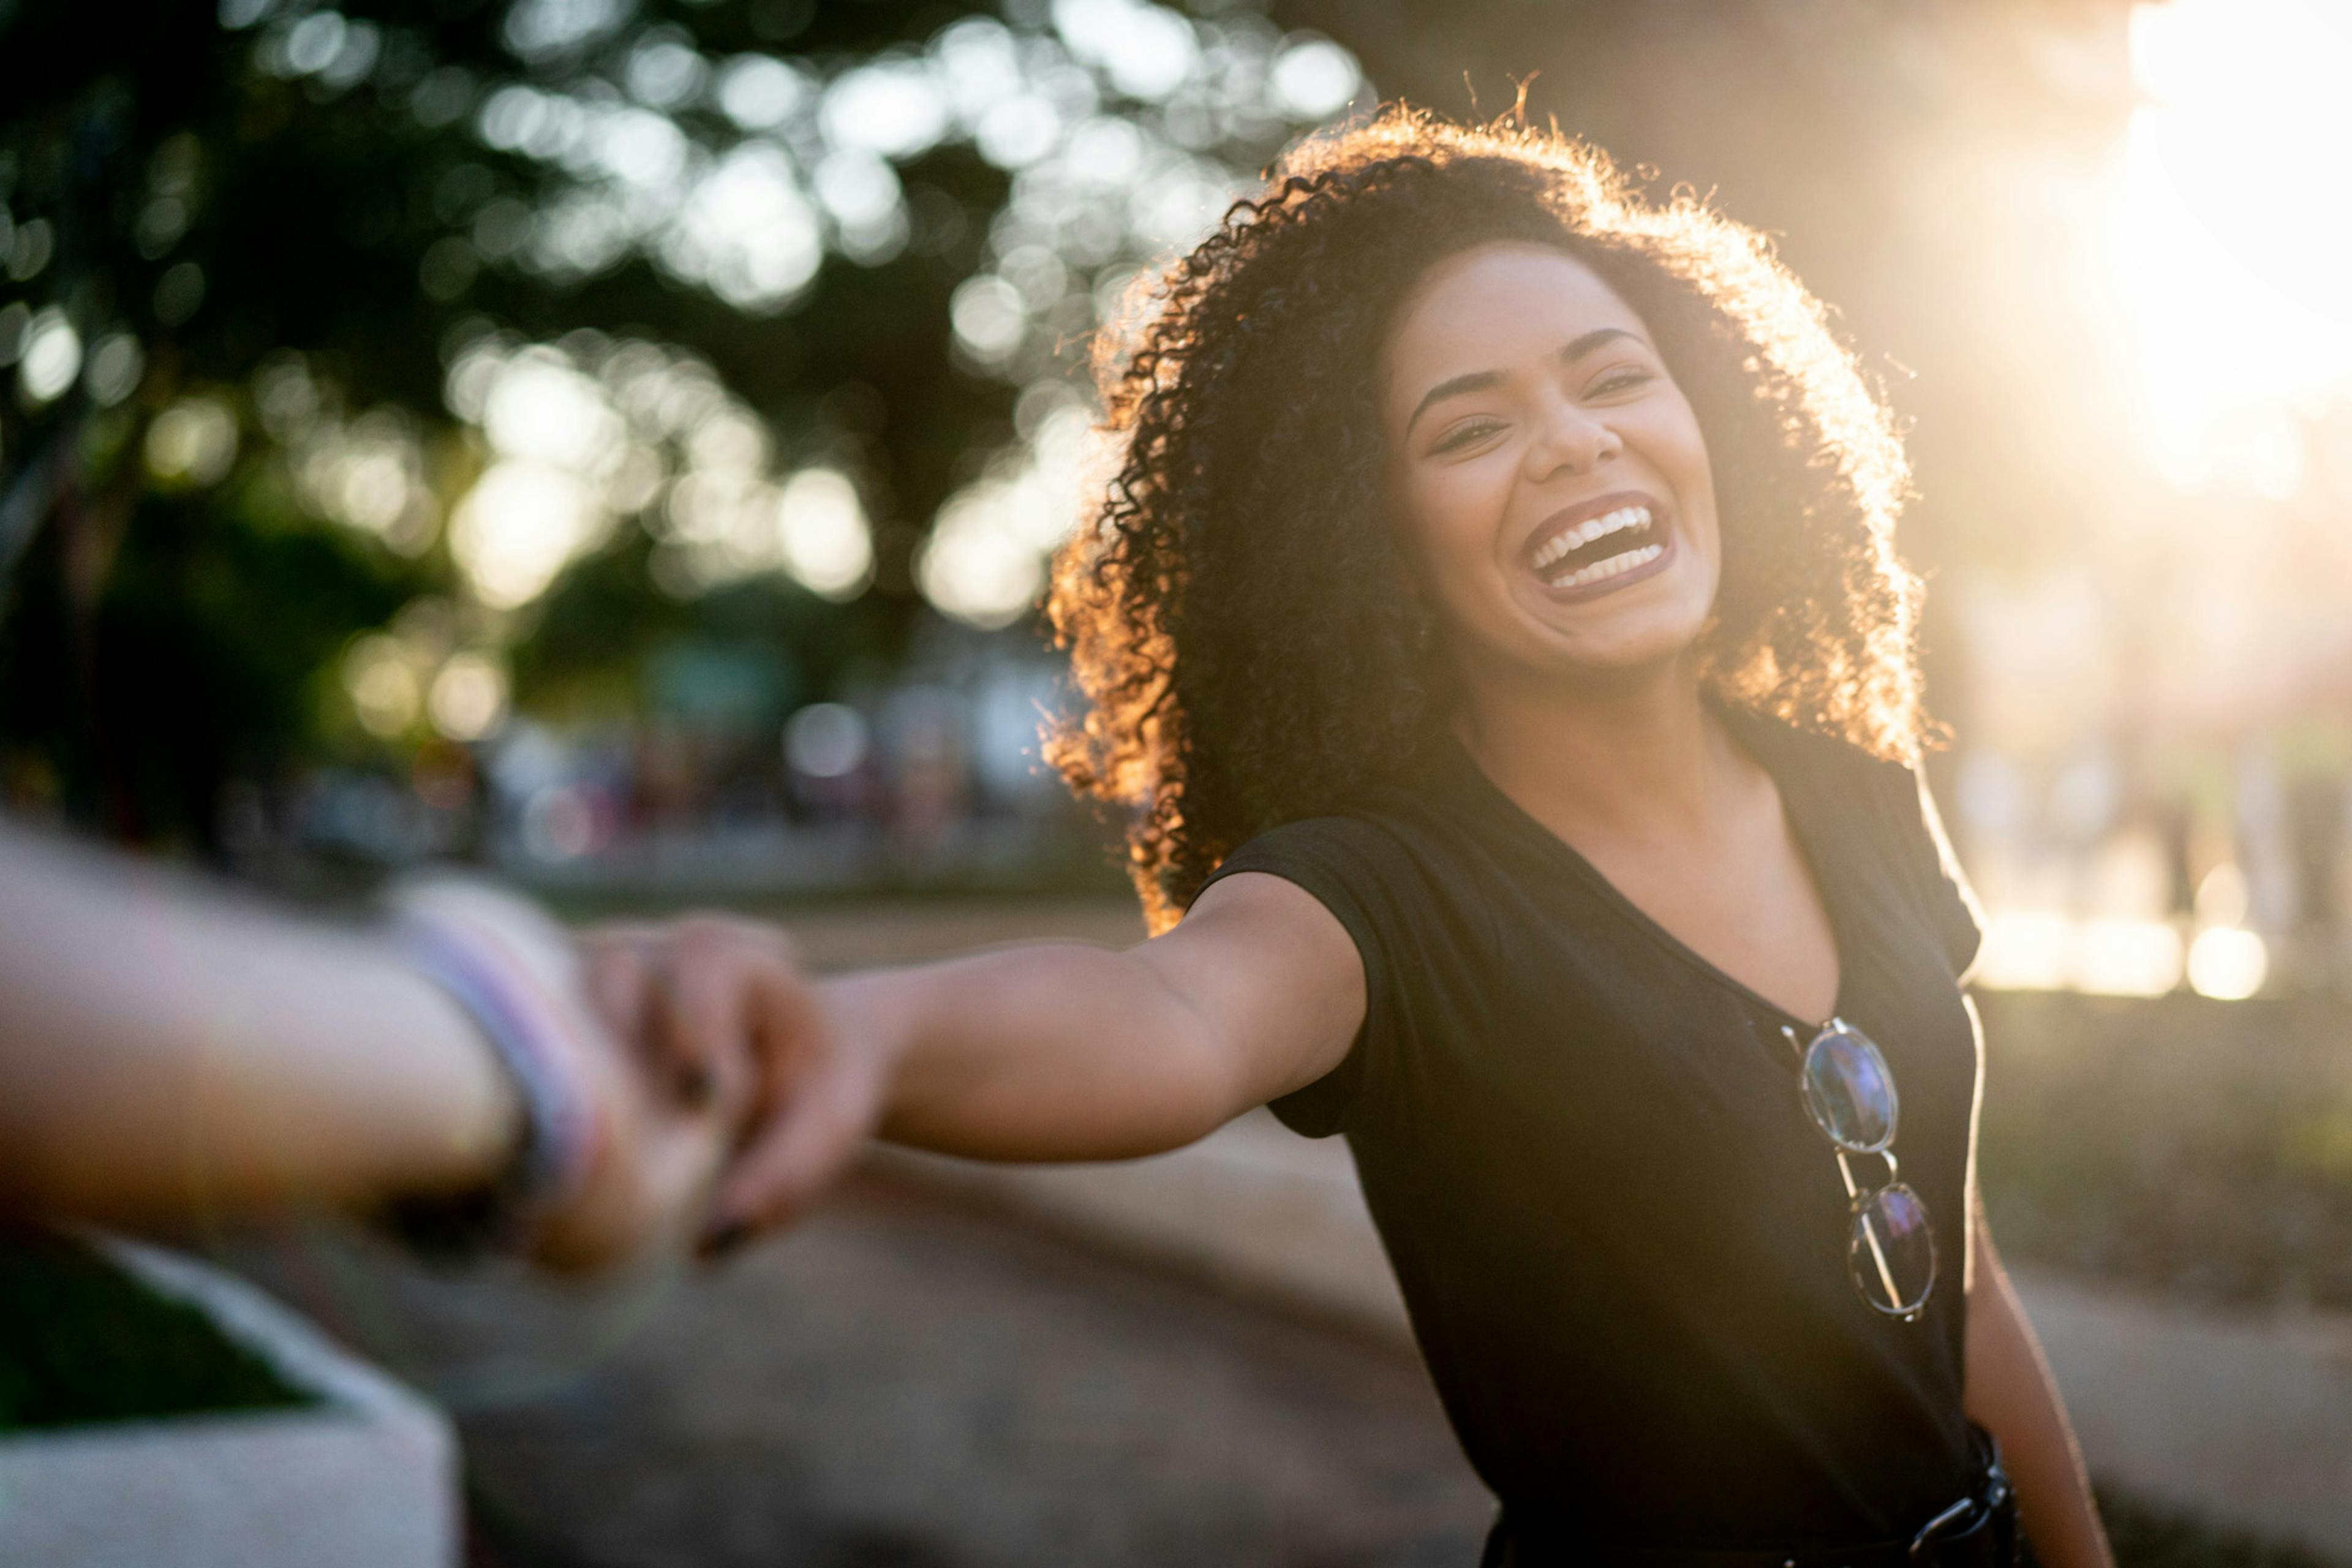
[611,113,2108,1568]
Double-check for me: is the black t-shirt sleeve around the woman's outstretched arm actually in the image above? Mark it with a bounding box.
[1202,818,1390,1138]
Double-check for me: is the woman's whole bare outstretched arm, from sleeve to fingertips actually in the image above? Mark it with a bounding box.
[590,875,1364,1243]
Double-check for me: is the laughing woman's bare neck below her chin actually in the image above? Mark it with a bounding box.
[1453,658,1727,839]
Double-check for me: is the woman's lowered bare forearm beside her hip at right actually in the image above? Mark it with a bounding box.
[1966,1215,2114,1568]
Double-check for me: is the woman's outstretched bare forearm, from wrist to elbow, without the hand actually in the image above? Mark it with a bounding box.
[826,943,1249,1159]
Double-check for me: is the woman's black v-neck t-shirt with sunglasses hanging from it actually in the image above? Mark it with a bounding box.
[1216,710,1980,1549]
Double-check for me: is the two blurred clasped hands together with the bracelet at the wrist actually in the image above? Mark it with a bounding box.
[390,879,887,1272]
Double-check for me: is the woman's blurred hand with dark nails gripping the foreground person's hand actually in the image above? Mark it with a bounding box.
[581,914,889,1256]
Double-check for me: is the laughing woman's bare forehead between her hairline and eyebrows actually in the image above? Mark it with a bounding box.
[1385,242,1649,399]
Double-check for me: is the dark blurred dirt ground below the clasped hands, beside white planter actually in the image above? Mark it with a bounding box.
[216,1180,1491,1568]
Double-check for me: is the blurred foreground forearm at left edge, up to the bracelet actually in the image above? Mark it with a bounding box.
[0,825,520,1223]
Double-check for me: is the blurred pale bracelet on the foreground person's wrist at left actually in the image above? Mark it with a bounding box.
[386,879,607,1253]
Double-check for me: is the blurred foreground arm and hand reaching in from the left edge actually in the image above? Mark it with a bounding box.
[0,823,725,1267]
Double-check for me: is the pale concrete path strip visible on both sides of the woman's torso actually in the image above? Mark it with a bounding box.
[882,1112,2352,1554]
